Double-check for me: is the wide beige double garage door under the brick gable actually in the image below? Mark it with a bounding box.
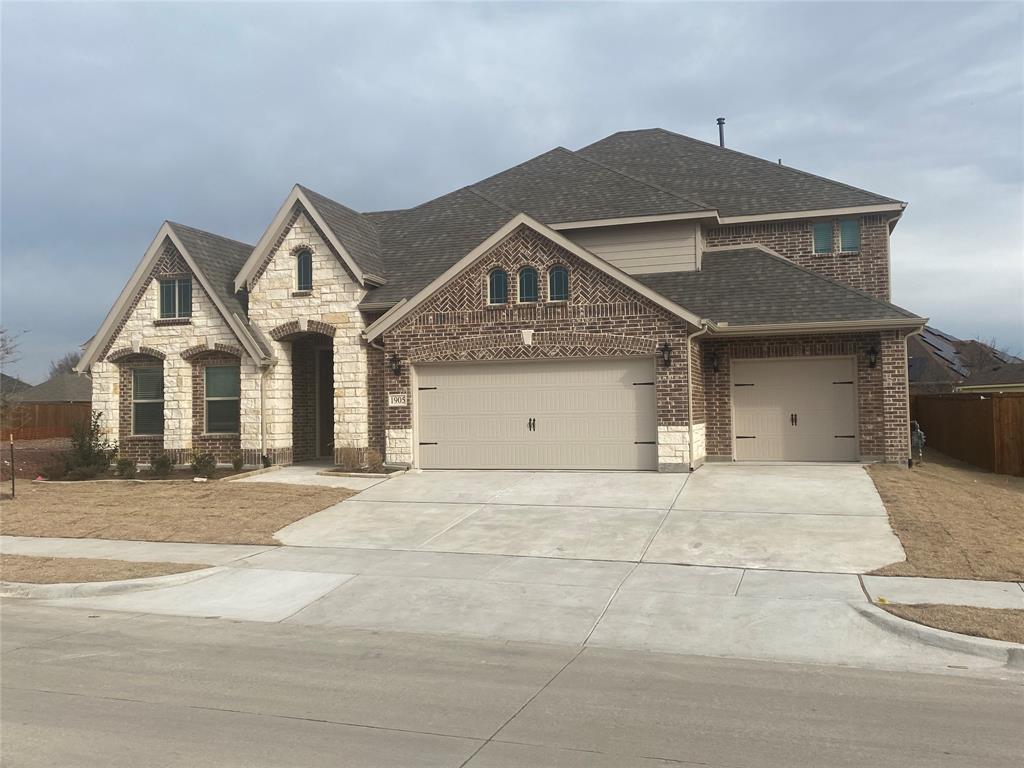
[416,358,657,469]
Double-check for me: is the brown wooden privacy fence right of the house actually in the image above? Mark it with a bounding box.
[910,392,1024,476]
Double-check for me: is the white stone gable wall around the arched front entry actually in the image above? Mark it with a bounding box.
[243,209,370,463]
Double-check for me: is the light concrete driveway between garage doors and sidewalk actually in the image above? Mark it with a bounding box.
[278,465,903,573]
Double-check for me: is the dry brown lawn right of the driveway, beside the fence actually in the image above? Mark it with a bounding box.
[867,452,1024,582]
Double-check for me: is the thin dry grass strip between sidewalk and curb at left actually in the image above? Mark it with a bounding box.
[0,555,203,584]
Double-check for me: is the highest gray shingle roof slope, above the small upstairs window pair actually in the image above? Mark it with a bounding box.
[577,128,899,216]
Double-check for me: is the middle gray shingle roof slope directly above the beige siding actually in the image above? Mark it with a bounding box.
[468,146,706,225]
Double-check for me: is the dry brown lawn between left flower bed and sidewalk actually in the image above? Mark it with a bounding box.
[0,480,353,544]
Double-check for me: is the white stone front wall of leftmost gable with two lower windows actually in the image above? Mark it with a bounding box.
[91,241,258,463]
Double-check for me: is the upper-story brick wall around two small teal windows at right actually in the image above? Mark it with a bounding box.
[703,215,891,301]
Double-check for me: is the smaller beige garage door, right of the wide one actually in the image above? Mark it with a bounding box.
[732,357,857,462]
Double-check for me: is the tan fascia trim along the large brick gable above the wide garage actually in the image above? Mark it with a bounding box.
[364,213,707,341]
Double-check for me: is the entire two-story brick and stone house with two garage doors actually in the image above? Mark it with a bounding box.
[79,129,926,471]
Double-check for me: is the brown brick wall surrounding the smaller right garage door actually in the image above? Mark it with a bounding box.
[700,331,909,463]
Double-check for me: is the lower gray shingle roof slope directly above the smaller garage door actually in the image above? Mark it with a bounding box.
[634,249,916,326]
